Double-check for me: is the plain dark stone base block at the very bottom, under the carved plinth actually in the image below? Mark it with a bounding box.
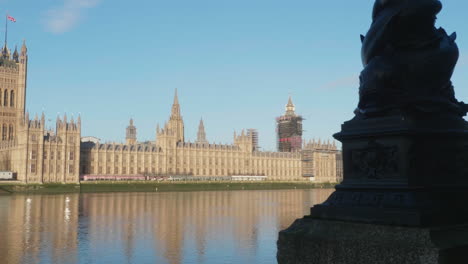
[277,217,468,264]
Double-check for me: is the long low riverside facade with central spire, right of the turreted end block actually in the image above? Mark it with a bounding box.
[80,91,340,182]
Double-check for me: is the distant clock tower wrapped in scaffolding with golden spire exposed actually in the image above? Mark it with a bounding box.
[276,96,303,152]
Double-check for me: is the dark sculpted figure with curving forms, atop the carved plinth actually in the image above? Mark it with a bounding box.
[356,0,468,117]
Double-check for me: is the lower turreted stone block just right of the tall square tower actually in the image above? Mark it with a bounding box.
[10,113,81,183]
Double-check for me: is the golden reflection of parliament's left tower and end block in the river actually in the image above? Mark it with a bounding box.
[0,194,79,263]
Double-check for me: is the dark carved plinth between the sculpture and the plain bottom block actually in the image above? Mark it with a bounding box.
[311,115,468,227]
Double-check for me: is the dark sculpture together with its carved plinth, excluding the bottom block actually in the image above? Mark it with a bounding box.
[311,0,468,226]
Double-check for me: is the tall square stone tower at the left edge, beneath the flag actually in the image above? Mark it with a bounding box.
[0,42,28,141]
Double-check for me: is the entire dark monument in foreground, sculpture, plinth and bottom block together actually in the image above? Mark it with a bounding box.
[277,0,468,264]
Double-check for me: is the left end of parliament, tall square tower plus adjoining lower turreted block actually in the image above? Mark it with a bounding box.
[0,43,81,183]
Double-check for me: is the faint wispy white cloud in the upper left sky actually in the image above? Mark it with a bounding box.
[45,0,100,34]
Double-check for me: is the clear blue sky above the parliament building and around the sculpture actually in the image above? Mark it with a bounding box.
[0,0,468,150]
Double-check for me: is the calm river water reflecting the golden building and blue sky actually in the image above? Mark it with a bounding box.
[0,189,332,264]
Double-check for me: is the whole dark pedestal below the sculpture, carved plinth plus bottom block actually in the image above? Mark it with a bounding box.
[277,114,468,264]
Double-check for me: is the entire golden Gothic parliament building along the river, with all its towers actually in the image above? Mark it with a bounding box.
[0,42,342,183]
